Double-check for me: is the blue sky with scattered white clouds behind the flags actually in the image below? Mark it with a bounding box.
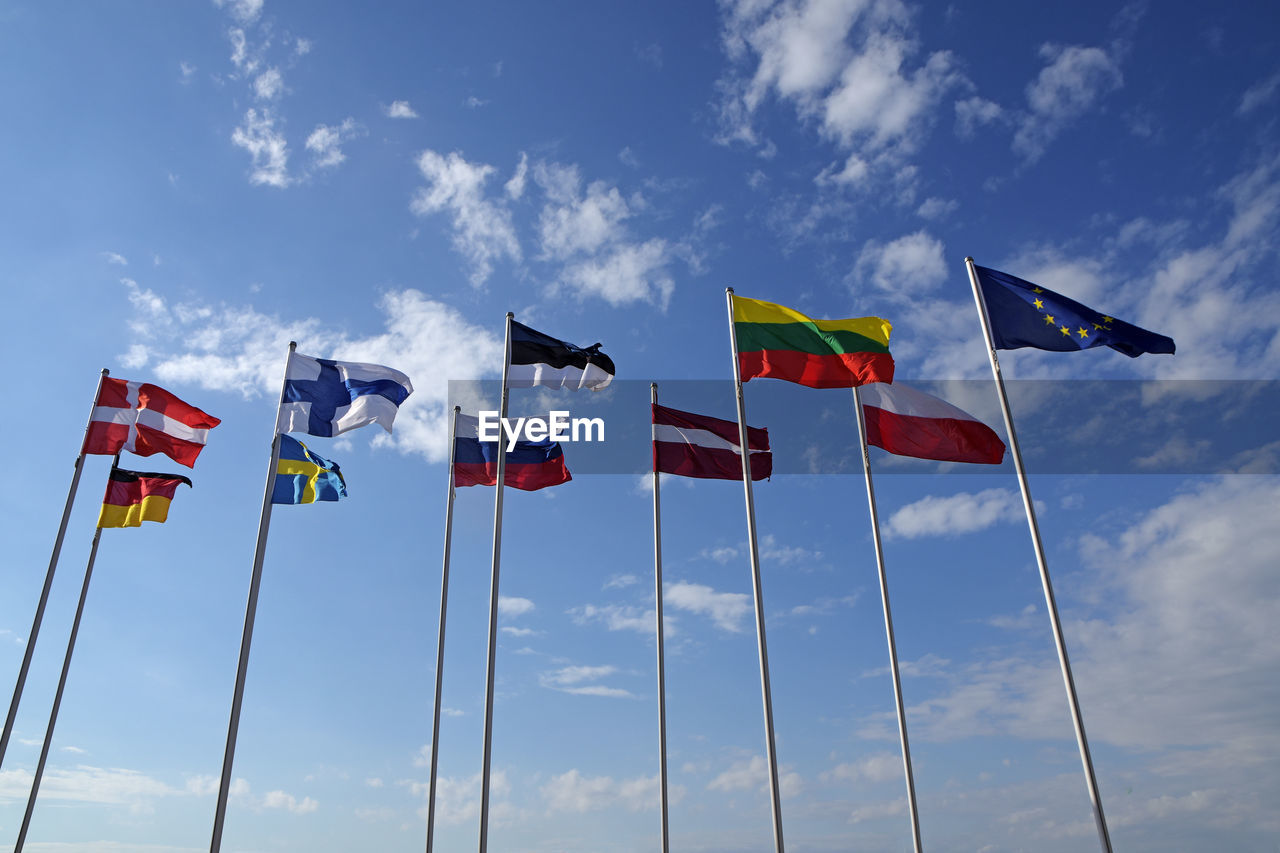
[0,0,1280,853]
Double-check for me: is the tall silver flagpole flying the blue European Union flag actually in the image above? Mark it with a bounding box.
[964,257,1111,853]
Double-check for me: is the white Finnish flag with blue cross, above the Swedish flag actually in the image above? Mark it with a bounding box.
[275,352,413,437]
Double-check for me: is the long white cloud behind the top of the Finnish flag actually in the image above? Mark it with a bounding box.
[124,279,502,461]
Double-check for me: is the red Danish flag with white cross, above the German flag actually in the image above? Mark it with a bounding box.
[82,378,221,467]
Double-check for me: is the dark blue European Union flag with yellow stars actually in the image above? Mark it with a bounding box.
[974,265,1174,359]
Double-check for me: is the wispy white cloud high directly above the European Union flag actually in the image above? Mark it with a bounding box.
[1014,45,1124,161]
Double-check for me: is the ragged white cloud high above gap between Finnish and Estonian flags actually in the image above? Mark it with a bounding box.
[410,151,521,286]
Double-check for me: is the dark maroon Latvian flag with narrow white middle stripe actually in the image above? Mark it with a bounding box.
[653,405,773,480]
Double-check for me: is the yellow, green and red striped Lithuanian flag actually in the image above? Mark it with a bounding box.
[733,296,893,388]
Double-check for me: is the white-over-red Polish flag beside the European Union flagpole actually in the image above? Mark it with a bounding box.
[858,383,1005,465]
